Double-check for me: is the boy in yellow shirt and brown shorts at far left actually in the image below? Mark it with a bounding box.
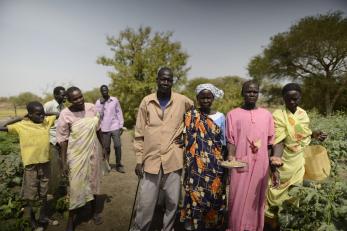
[0,102,57,230]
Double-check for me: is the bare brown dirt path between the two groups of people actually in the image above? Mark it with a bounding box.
[46,131,188,231]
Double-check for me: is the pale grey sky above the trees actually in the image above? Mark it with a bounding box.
[0,0,347,96]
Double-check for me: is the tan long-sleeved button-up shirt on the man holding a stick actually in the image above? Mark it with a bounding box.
[134,92,193,174]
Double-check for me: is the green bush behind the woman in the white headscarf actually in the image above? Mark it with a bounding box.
[182,76,244,114]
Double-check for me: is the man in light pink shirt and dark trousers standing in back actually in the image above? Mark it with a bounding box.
[95,85,125,173]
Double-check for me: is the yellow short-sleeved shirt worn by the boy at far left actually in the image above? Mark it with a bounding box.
[7,116,56,166]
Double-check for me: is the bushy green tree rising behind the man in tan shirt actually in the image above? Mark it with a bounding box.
[97,27,189,126]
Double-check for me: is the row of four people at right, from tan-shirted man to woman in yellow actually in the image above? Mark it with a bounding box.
[131,68,327,231]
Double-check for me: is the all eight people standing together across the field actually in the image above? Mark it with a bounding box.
[0,67,327,231]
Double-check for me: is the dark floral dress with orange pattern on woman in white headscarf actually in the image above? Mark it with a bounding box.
[180,109,226,230]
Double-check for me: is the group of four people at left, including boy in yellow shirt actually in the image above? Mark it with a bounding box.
[0,85,125,231]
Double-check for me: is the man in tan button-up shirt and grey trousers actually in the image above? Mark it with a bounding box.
[131,67,193,231]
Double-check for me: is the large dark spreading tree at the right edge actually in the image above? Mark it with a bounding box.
[248,11,347,115]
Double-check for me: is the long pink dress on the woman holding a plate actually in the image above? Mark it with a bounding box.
[226,108,274,231]
